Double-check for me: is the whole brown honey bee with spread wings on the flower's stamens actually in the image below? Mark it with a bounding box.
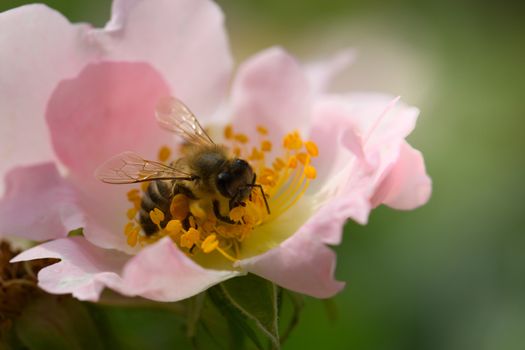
[95,97,270,236]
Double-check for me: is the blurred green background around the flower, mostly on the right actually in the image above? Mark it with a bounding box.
[0,0,525,350]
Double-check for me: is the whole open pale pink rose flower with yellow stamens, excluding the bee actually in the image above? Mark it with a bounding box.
[0,0,431,301]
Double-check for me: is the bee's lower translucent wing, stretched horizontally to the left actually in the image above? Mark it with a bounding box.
[95,152,195,184]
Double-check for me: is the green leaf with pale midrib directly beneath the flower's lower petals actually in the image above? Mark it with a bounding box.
[210,274,280,349]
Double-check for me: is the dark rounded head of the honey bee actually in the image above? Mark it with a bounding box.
[217,158,254,202]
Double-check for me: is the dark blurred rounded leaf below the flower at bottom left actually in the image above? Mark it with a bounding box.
[15,295,103,350]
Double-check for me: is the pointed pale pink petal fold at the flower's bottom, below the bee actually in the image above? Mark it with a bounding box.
[119,238,239,301]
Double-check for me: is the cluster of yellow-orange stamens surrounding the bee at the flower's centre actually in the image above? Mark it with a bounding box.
[124,126,319,262]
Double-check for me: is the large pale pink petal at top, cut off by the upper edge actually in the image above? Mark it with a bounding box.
[96,0,232,116]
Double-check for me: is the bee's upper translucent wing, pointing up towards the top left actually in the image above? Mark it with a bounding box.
[155,97,214,145]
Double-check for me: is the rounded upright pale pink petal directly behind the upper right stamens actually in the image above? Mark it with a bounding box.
[232,48,310,143]
